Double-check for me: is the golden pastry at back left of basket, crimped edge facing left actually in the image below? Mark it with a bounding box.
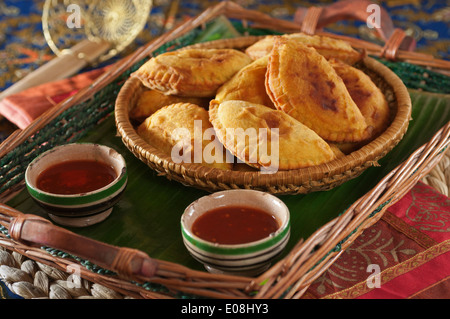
[134,48,252,97]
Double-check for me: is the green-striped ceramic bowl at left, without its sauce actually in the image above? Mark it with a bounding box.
[25,143,128,227]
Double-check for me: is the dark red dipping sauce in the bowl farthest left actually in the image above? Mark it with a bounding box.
[36,160,117,195]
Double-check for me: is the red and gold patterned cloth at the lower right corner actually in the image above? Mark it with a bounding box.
[303,183,450,299]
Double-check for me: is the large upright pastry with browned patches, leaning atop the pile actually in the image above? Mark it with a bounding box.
[266,37,372,142]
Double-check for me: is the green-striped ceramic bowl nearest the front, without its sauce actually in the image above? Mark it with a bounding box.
[181,189,290,276]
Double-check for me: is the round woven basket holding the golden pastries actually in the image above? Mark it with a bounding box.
[115,37,411,194]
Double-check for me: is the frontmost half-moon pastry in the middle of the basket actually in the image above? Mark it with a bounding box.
[209,100,335,171]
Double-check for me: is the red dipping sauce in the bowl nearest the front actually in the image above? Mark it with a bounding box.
[192,206,280,244]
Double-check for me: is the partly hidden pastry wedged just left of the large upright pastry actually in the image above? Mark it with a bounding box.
[216,56,275,109]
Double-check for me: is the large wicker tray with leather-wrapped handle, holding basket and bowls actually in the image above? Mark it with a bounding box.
[0,2,450,298]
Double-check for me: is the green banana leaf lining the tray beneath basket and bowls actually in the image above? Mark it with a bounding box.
[7,91,450,270]
